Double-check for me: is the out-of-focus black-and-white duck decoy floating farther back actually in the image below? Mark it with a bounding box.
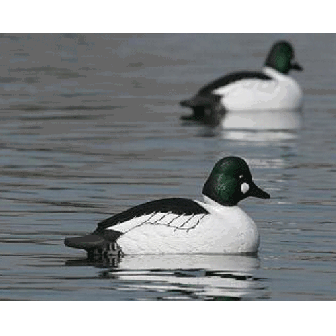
[180,41,303,125]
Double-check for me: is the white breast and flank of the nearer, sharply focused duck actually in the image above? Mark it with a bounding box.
[108,197,259,254]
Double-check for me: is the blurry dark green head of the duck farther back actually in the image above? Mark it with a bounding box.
[265,41,303,74]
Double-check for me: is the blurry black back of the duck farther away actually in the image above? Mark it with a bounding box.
[198,71,272,95]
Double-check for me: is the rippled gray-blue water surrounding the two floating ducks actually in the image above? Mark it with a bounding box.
[0,34,336,300]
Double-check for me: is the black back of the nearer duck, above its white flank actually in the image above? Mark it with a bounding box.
[94,198,209,234]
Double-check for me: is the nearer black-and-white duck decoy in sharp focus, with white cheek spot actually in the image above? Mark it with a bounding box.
[64,156,270,258]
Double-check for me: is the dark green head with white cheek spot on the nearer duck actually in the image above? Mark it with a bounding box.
[202,156,270,206]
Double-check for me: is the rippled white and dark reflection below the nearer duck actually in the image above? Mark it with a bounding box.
[66,255,268,300]
